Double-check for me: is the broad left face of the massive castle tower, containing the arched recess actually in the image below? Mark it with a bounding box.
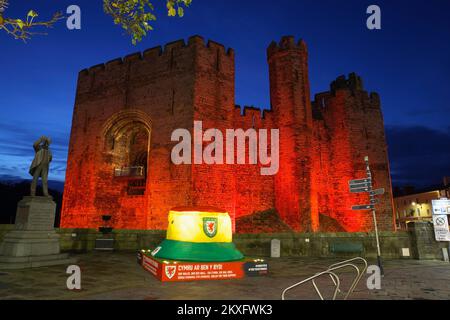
[61,38,205,229]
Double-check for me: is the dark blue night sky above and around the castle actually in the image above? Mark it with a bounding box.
[0,0,450,187]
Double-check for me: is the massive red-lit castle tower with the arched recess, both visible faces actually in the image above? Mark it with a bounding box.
[61,36,244,229]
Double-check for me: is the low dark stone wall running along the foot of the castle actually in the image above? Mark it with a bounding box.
[0,225,432,260]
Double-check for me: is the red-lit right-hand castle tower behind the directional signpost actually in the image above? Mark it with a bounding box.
[313,74,393,231]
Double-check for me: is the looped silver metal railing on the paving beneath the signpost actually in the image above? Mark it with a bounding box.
[281,257,367,300]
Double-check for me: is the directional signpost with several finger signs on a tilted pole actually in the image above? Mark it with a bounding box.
[348,156,385,275]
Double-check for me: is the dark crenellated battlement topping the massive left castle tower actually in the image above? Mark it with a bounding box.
[79,35,234,76]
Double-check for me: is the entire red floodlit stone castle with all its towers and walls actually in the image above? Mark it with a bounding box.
[61,36,394,232]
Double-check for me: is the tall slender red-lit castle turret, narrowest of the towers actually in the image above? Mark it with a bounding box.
[267,37,318,231]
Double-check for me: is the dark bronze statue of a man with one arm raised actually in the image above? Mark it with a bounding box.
[29,136,52,197]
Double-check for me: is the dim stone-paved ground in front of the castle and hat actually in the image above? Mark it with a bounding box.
[0,252,450,300]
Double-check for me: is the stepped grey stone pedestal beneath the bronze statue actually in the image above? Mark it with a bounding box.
[0,197,75,269]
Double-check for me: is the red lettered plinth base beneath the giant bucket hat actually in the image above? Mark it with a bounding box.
[137,251,269,282]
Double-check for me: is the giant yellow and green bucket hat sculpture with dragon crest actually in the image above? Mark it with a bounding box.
[151,207,244,262]
